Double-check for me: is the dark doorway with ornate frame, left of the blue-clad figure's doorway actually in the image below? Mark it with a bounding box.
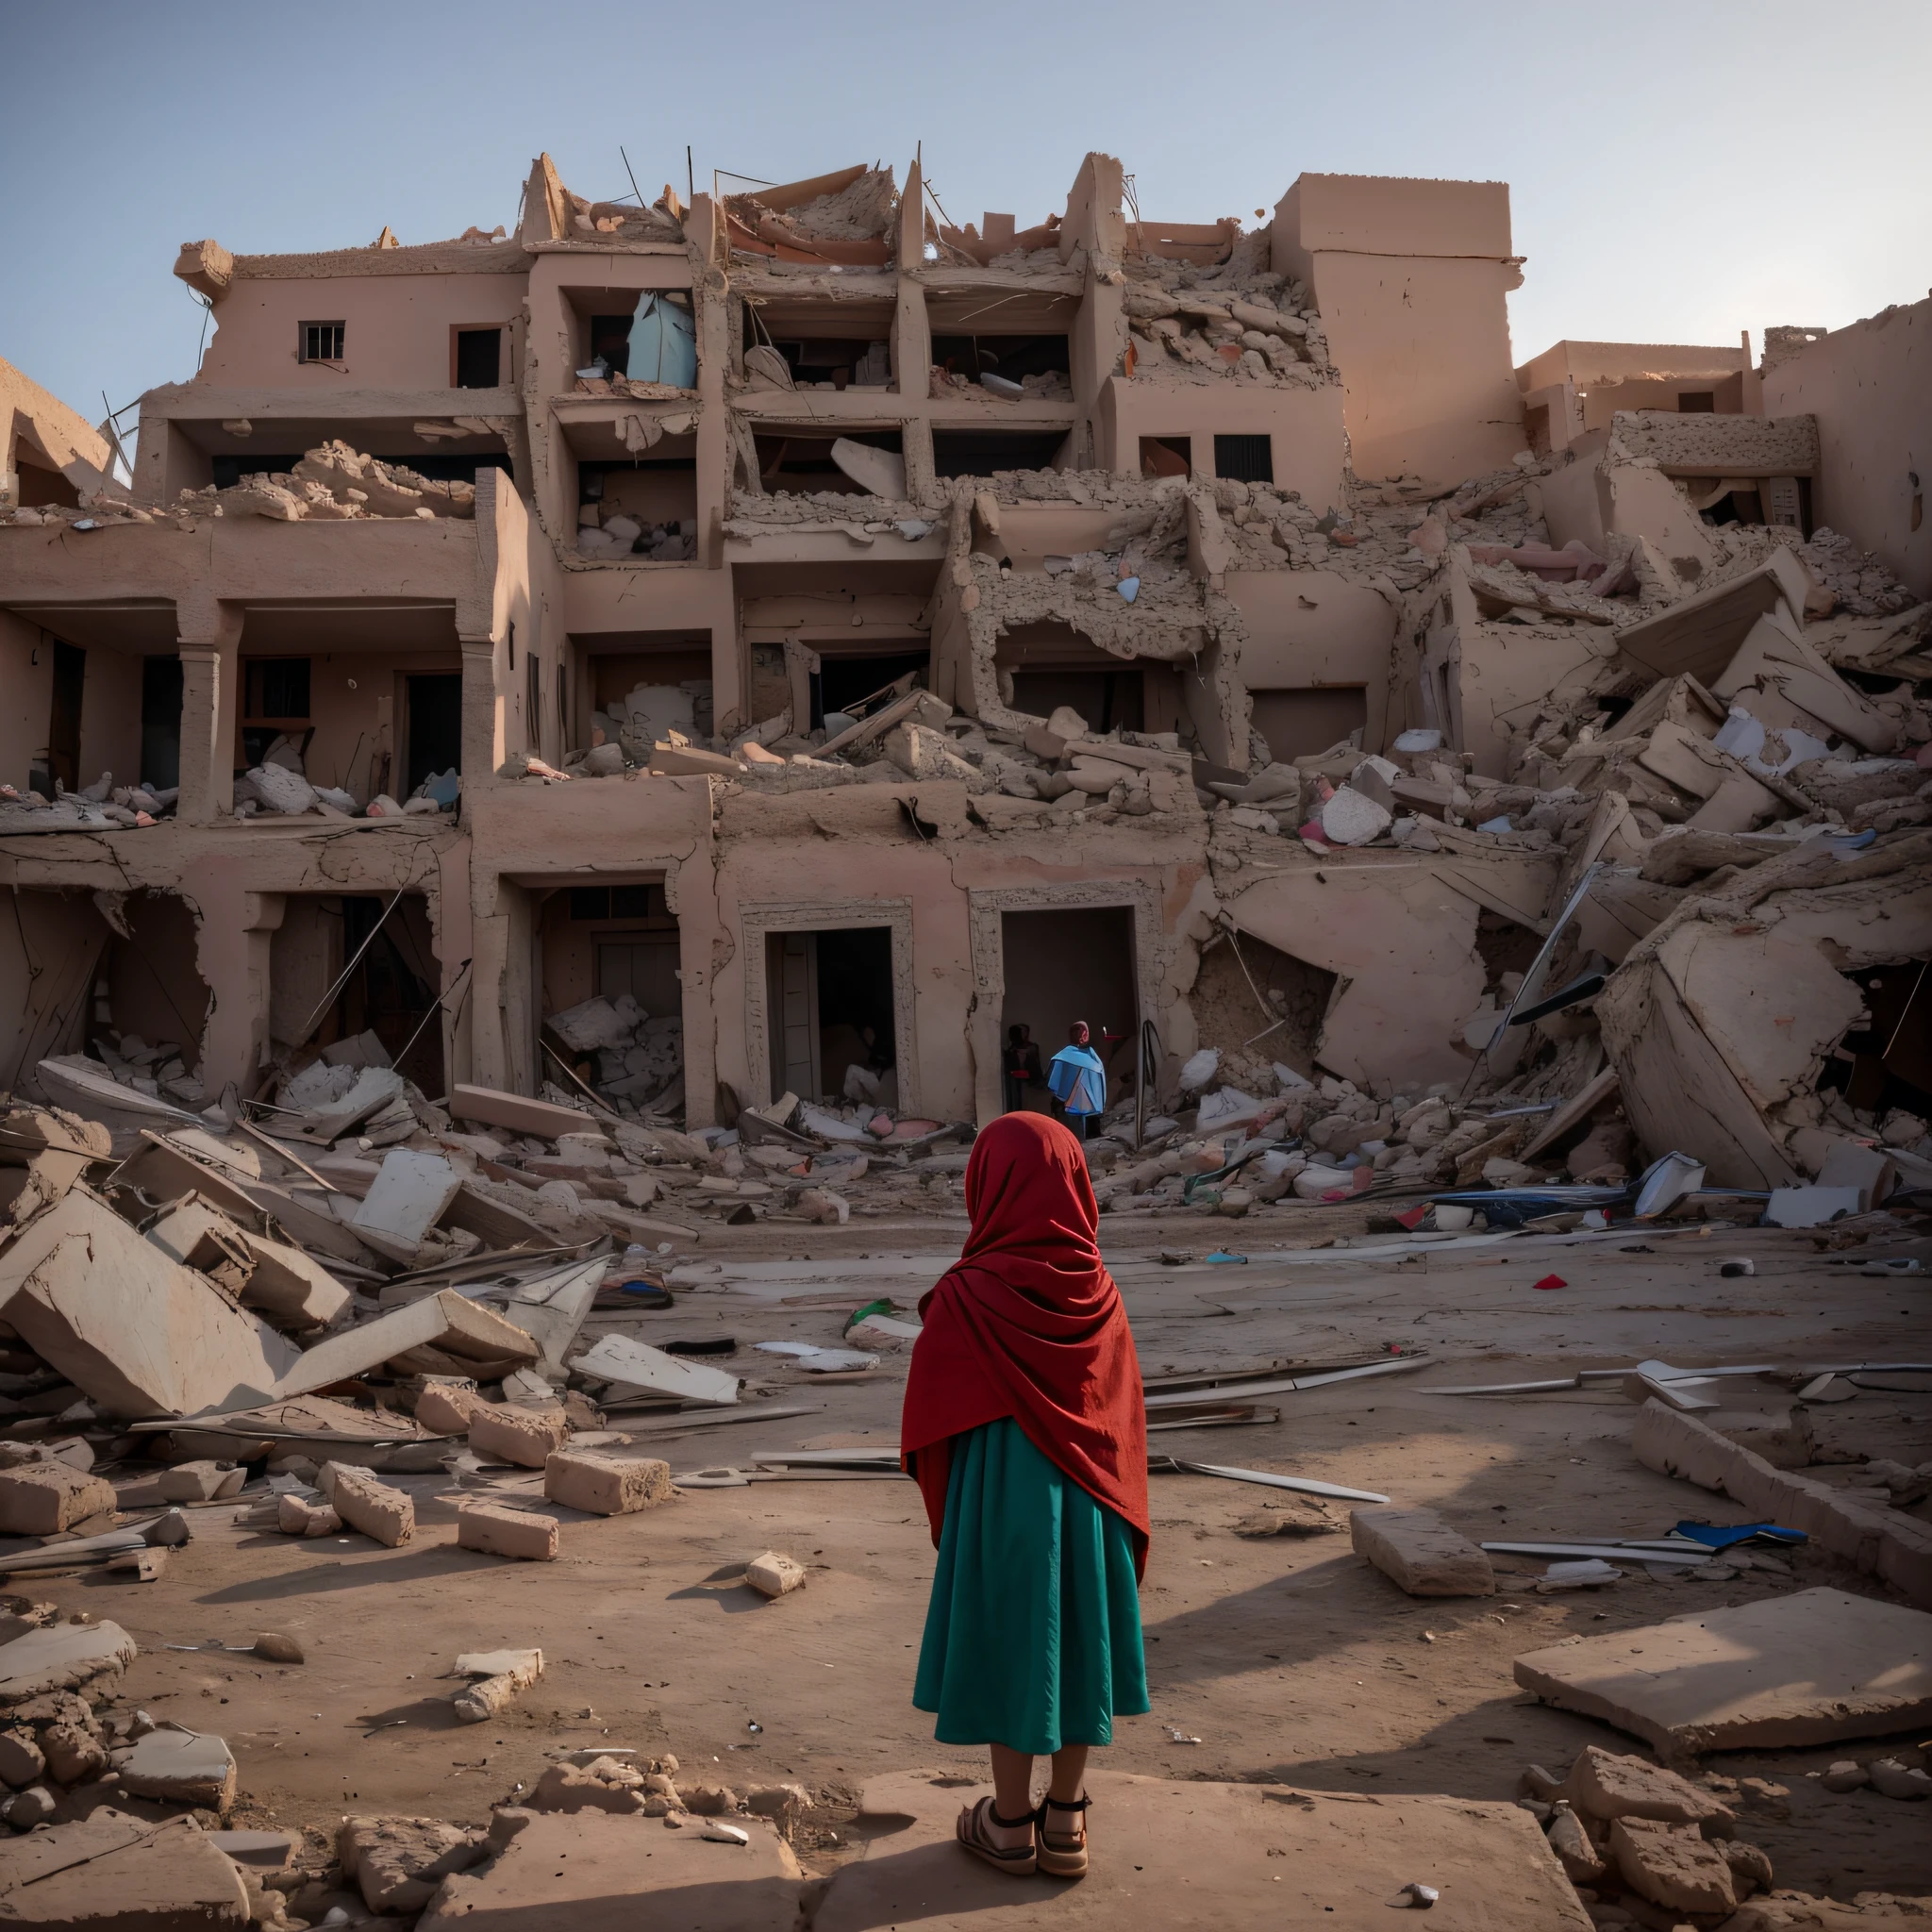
[765,925,898,1105]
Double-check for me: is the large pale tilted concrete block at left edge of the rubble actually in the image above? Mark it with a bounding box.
[0,1186,299,1420]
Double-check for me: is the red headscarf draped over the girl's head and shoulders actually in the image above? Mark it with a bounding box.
[900,1113,1150,1569]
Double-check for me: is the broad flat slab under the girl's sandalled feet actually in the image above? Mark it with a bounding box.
[815,1772,1591,1932]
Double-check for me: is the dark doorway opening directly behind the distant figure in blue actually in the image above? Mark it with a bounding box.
[999,907,1140,1113]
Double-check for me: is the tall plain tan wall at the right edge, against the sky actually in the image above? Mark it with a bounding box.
[1764,297,1932,597]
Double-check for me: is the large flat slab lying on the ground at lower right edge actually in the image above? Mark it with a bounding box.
[1515,1591,1932,1757]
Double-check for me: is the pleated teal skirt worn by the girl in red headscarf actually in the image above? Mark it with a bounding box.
[912,1416,1150,1757]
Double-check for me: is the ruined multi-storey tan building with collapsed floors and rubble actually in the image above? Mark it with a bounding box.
[0,155,1932,1202]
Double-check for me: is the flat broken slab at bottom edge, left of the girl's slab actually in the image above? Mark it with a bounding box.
[415,1810,799,1932]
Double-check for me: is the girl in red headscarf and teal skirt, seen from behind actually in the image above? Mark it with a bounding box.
[900,1113,1152,1878]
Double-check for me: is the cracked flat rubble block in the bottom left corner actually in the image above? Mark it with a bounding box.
[0,1801,249,1932]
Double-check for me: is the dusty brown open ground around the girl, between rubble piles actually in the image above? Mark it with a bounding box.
[41,1211,1932,1899]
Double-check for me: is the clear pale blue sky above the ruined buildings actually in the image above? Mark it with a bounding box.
[0,0,1932,438]
